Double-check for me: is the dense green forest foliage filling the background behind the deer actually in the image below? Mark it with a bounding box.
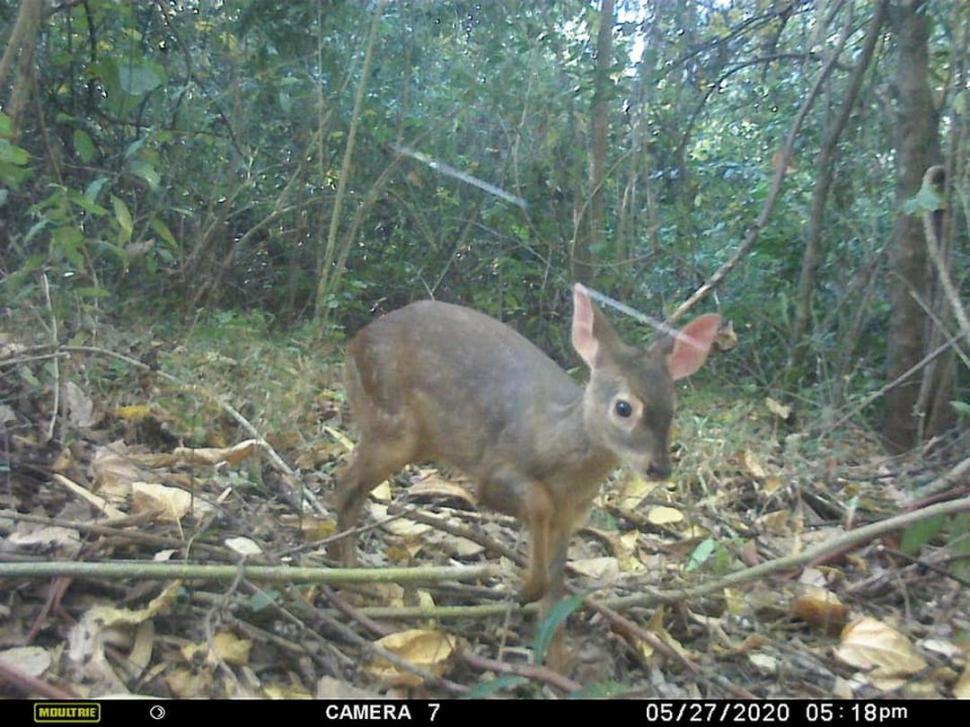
[0,0,966,420]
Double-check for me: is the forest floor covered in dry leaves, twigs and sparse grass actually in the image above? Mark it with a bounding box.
[0,315,970,698]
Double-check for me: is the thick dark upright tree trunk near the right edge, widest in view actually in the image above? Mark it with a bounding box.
[882,2,940,451]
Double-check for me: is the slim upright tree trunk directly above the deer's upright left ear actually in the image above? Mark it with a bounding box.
[572,0,614,283]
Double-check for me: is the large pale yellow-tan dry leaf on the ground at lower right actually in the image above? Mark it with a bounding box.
[835,617,927,679]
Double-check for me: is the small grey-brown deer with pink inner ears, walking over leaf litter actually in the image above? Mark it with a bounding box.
[336,284,720,605]
